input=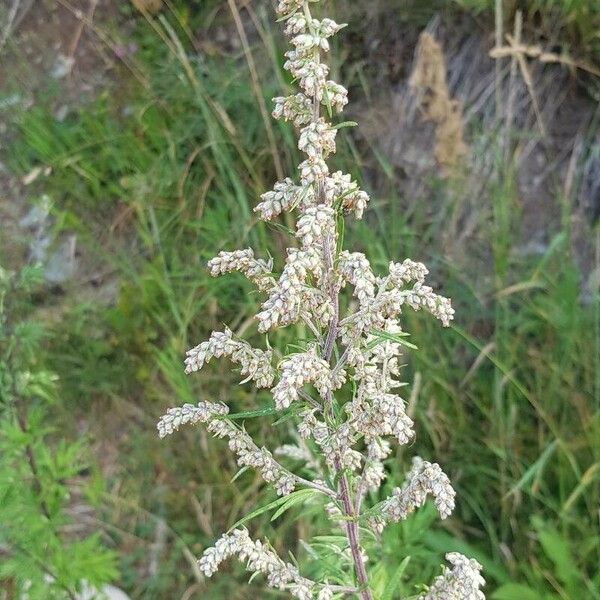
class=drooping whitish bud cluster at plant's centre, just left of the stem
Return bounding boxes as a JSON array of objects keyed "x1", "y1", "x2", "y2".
[{"x1": 271, "y1": 346, "x2": 331, "y2": 410}]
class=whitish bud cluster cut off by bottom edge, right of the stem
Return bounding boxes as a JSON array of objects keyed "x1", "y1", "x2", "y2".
[{"x1": 418, "y1": 552, "x2": 485, "y2": 600}]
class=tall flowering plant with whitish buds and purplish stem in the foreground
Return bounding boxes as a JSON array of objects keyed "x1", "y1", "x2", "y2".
[{"x1": 158, "y1": 0, "x2": 483, "y2": 600}]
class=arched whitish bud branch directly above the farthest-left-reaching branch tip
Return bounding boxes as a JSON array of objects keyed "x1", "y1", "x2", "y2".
[{"x1": 185, "y1": 328, "x2": 275, "y2": 387}]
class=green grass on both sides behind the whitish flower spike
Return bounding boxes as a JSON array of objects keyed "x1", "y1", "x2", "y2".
[{"x1": 1, "y1": 2, "x2": 600, "y2": 600}]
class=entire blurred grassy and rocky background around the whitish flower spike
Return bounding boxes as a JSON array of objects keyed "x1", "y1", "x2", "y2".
[{"x1": 0, "y1": 0, "x2": 600, "y2": 600}]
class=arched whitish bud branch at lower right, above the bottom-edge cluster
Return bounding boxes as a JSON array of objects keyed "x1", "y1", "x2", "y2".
[{"x1": 383, "y1": 456, "x2": 456, "y2": 522}]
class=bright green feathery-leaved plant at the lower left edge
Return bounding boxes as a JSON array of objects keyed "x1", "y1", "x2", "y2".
[{"x1": 0, "y1": 268, "x2": 117, "y2": 600}]
